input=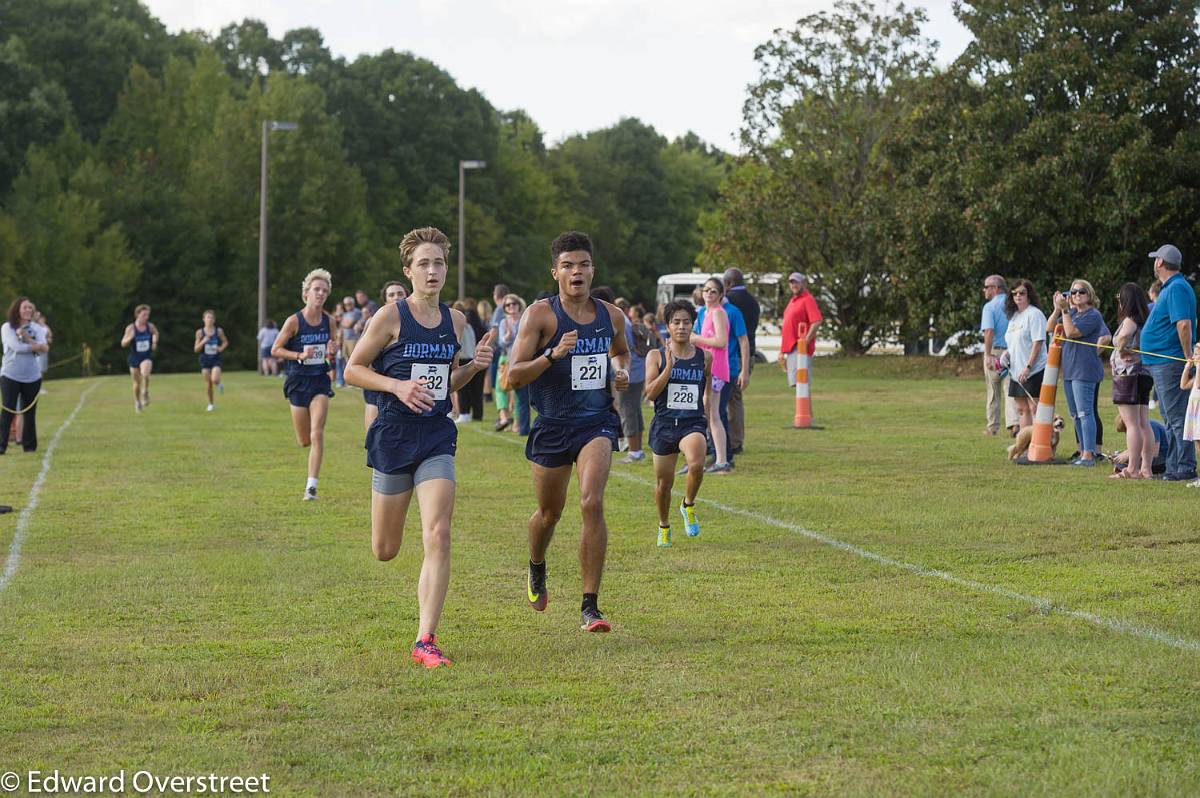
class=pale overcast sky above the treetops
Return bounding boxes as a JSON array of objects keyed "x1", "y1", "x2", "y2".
[{"x1": 143, "y1": 0, "x2": 970, "y2": 150}]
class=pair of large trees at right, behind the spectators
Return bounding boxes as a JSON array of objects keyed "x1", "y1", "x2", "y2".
[{"x1": 701, "y1": 0, "x2": 1200, "y2": 352}]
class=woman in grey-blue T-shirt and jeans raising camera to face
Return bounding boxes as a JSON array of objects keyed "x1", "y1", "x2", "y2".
[{"x1": 1046, "y1": 280, "x2": 1112, "y2": 468}]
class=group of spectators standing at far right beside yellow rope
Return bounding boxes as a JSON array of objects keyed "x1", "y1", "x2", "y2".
[{"x1": 979, "y1": 244, "x2": 1200, "y2": 487}]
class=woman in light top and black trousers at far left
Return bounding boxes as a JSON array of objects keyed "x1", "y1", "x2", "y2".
[{"x1": 0, "y1": 296, "x2": 50, "y2": 455}]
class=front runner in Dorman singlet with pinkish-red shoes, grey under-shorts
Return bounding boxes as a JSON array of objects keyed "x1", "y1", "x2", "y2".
[{"x1": 346, "y1": 227, "x2": 496, "y2": 667}]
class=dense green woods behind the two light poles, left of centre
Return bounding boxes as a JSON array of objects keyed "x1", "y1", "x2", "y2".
[{"x1": 0, "y1": 0, "x2": 730, "y2": 368}]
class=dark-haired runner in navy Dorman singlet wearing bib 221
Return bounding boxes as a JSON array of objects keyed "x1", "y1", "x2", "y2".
[{"x1": 509, "y1": 232, "x2": 629, "y2": 631}]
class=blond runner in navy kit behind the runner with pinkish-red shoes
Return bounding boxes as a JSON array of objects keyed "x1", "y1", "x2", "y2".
[{"x1": 271, "y1": 269, "x2": 334, "y2": 502}]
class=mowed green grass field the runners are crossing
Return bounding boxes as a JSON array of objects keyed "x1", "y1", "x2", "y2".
[{"x1": 0, "y1": 359, "x2": 1200, "y2": 796}]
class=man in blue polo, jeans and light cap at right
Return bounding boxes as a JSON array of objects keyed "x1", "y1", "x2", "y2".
[{"x1": 1141, "y1": 244, "x2": 1196, "y2": 481}]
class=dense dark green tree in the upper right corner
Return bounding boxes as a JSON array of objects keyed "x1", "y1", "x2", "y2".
[{"x1": 940, "y1": 0, "x2": 1200, "y2": 317}]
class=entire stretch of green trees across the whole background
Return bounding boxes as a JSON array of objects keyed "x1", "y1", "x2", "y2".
[{"x1": 0, "y1": 0, "x2": 1200, "y2": 367}]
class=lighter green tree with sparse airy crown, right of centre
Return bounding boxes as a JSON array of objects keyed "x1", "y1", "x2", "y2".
[{"x1": 706, "y1": 0, "x2": 934, "y2": 353}]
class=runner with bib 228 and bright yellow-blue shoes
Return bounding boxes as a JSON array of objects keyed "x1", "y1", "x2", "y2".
[{"x1": 646, "y1": 300, "x2": 713, "y2": 547}]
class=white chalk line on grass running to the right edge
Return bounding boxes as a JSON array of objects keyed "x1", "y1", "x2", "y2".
[{"x1": 474, "y1": 430, "x2": 1200, "y2": 652}]
